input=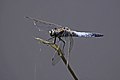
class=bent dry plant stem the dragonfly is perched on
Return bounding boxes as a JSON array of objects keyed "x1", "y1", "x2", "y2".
[{"x1": 35, "y1": 38, "x2": 78, "y2": 80}]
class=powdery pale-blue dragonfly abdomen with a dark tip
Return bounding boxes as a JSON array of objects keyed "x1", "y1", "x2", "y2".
[{"x1": 72, "y1": 31, "x2": 103, "y2": 37}]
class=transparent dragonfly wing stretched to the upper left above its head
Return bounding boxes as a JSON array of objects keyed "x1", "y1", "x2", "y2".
[{"x1": 25, "y1": 17, "x2": 62, "y2": 31}]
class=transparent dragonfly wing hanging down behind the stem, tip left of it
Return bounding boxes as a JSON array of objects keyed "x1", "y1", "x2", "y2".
[{"x1": 52, "y1": 41, "x2": 64, "y2": 66}]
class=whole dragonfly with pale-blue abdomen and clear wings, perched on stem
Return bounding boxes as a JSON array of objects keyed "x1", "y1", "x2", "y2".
[{"x1": 26, "y1": 17, "x2": 103, "y2": 65}]
